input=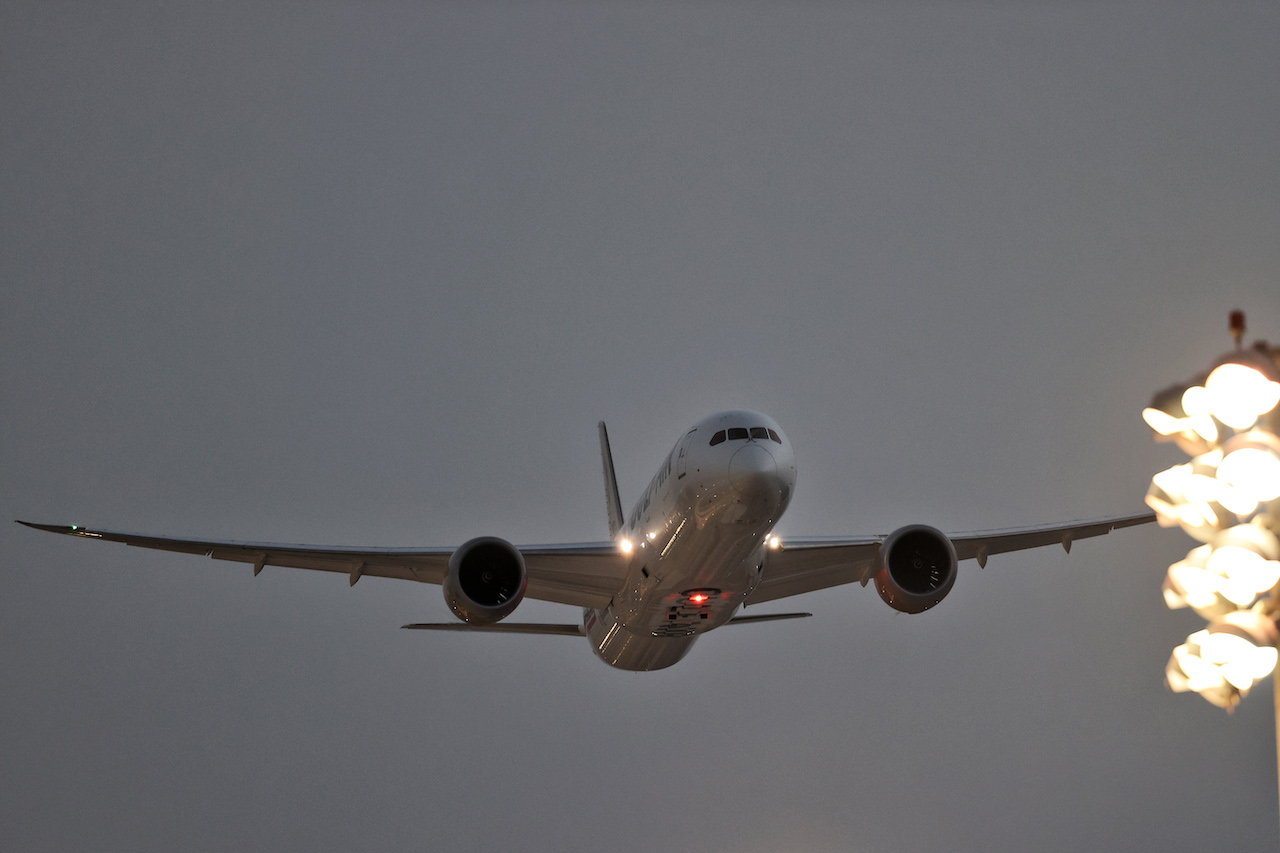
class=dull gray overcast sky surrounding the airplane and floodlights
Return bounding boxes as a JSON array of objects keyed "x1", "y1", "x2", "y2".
[{"x1": 0, "y1": 3, "x2": 1280, "y2": 853}]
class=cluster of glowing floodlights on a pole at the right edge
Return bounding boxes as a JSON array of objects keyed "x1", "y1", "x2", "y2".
[{"x1": 1142, "y1": 311, "x2": 1280, "y2": 809}]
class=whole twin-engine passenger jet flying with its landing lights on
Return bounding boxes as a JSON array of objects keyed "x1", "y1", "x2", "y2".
[{"x1": 18, "y1": 410, "x2": 1156, "y2": 671}]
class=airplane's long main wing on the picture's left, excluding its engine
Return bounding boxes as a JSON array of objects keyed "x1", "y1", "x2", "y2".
[{"x1": 18, "y1": 521, "x2": 627, "y2": 607}]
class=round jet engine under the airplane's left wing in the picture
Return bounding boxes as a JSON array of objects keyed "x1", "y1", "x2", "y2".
[{"x1": 443, "y1": 537, "x2": 529, "y2": 625}]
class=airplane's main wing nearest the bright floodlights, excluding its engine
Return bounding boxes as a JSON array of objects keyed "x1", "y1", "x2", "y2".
[{"x1": 746, "y1": 512, "x2": 1156, "y2": 605}]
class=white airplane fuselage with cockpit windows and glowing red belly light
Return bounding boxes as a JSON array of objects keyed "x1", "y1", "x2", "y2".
[{"x1": 582, "y1": 410, "x2": 796, "y2": 670}]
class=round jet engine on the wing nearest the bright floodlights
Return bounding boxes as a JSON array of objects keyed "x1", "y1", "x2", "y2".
[{"x1": 876, "y1": 524, "x2": 959, "y2": 613}]
